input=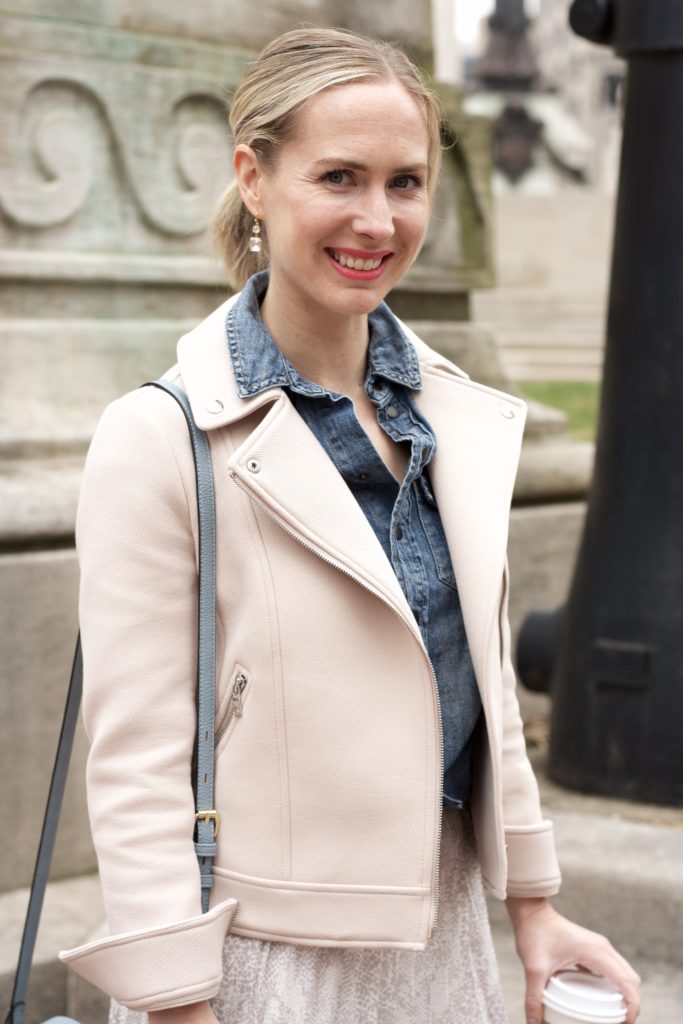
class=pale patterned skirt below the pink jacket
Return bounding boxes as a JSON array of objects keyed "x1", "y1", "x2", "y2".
[{"x1": 110, "y1": 811, "x2": 508, "y2": 1024}]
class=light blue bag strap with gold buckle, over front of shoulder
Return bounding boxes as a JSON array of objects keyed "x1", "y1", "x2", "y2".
[{"x1": 147, "y1": 380, "x2": 219, "y2": 913}]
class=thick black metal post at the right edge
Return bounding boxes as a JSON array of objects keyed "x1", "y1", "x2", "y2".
[{"x1": 549, "y1": 0, "x2": 683, "y2": 805}]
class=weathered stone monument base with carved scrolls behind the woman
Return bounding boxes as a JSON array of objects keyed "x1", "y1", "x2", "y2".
[{"x1": 0, "y1": 0, "x2": 492, "y2": 892}]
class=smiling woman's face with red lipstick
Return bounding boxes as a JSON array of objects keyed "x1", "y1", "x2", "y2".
[{"x1": 242, "y1": 82, "x2": 429, "y2": 315}]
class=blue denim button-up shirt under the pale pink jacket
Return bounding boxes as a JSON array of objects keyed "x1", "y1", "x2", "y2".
[{"x1": 226, "y1": 270, "x2": 481, "y2": 807}]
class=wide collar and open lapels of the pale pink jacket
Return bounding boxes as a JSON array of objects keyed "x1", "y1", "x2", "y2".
[{"x1": 178, "y1": 299, "x2": 525, "y2": 667}]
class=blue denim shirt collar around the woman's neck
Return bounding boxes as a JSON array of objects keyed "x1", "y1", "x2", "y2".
[{"x1": 226, "y1": 270, "x2": 422, "y2": 398}]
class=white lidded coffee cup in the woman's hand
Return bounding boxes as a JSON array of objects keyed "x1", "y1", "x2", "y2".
[{"x1": 543, "y1": 971, "x2": 626, "y2": 1024}]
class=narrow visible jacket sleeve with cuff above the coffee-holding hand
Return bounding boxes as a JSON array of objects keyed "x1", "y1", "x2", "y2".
[{"x1": 501, "y1": 564, "x2": 560, "y2": 896}]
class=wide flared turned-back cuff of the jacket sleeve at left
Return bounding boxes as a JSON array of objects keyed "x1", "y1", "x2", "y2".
[{"x1": 59, "y1": 899, "x2": 238, "y2": 1011}]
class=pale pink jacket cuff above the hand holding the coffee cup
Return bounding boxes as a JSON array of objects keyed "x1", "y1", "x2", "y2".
[{"x1": 505, "y1": 820, "x2": 561, "y2": 897}]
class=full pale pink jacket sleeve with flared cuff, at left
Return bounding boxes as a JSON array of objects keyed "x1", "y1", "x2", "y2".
[{"x1": 60, "y1": 388, "x2": 237, "y2": 1011}]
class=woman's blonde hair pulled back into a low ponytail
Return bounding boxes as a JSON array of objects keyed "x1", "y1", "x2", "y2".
[{"x1": 213, "y1": 29, "x2": 442, "y2": 288}]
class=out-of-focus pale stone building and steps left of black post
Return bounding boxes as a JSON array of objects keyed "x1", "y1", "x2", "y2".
[{"x1": 461, "y1": 0, "x2": 624, "y2": 382}]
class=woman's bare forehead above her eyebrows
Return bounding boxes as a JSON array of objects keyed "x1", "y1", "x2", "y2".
[{"x1": 285, "y1": 80, "x2": 429, "y2": 163}]
